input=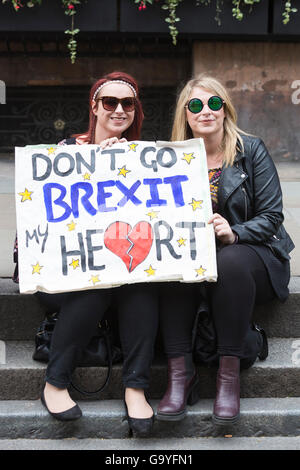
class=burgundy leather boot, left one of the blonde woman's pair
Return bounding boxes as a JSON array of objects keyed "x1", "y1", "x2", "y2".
[{"x1": 157, "y1": 354, "x2": 199, "y2": 421}]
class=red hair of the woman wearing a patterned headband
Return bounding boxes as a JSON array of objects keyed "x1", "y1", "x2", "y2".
[{"x1": 72, "y1": 72, "x2": 144, "y2": 144}]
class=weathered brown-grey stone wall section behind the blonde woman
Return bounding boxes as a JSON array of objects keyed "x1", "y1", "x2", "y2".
[{"x1": 193, "y1": 42, "x2": 300, "y2": 162}]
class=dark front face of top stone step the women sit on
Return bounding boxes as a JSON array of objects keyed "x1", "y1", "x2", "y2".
[{"x1": 0, "y1": 277, "x2": 300, "y2": 341}]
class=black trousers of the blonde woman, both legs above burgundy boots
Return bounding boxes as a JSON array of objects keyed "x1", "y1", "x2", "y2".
[{"x1": 160, "y1": 244, "x2": 275, "y2": 357}]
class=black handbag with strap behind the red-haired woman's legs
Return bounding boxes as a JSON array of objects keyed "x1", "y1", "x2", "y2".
[{"x1": 32, "y1": 313, "x2": 122, "y2": 395}]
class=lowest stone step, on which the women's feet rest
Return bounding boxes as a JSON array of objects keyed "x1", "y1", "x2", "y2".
[{"x1": 0, "y1": 397, "x2": 300, "y2": 442}]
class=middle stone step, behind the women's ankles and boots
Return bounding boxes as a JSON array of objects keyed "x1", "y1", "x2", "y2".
[{"x1": 0, "y1": 338, "x2": 300, "y2": 400}]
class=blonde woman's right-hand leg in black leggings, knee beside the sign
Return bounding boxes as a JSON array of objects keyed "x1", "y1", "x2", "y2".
[{"x1": 207, "y1": 244, "x2": 275, "y2": 356}]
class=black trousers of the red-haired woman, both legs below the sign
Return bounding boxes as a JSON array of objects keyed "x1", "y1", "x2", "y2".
[{"x1": 38, "y1": 283, "x2": 158, "y2": 388}]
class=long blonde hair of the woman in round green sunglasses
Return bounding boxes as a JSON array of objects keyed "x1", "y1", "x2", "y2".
[{"x1": 171, "y1": 74, "x2": 246, "y2": 166}]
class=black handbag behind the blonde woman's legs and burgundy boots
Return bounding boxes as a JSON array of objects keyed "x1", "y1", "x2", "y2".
[{"x1": 193, "y1": 302, "x2": 268, "y2": 369}]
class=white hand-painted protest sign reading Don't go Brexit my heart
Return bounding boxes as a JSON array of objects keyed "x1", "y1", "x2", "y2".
[{"x1": 16, "y1": 139, "x2": 217, "y2": 293}]
